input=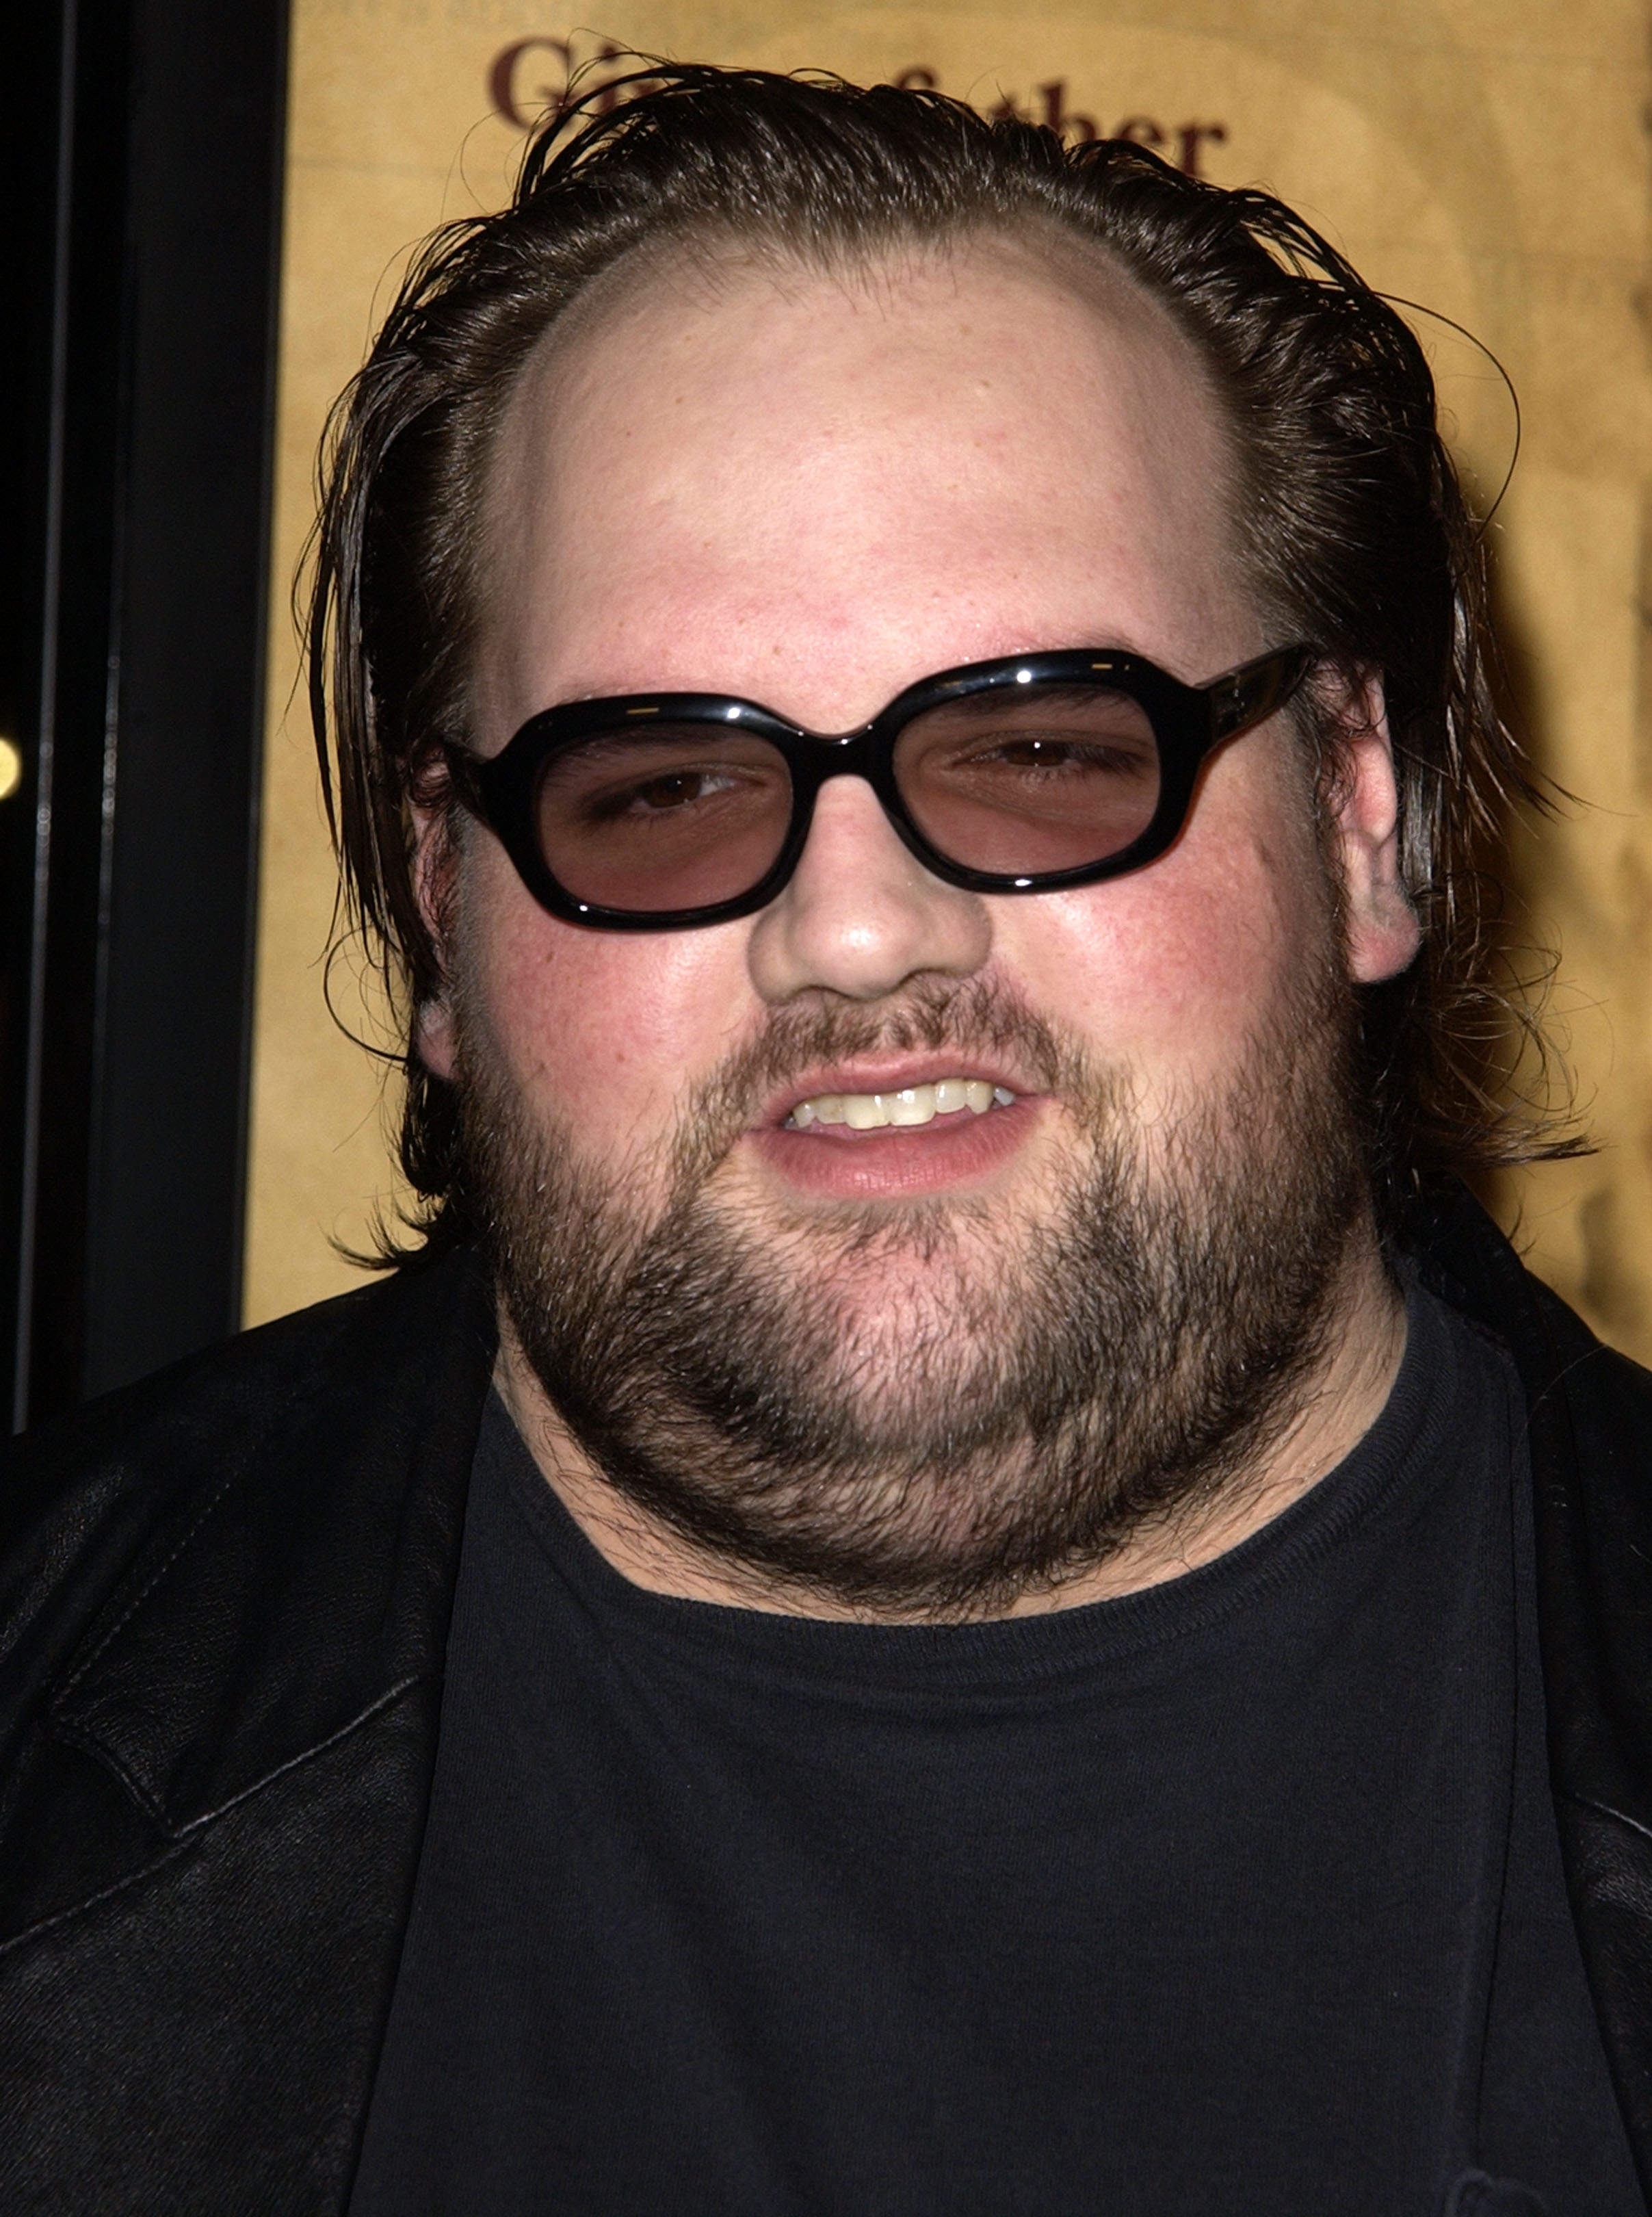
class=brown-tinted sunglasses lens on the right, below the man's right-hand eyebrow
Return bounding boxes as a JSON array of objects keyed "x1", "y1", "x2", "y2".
[{"x1": 893, "y1": 685, "x2": 1162, "y2": 878}]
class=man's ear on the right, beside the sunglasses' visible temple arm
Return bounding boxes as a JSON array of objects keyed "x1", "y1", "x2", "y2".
[{"x1": 1322, "y1": 672, "x2": 1421, "y2": 985}]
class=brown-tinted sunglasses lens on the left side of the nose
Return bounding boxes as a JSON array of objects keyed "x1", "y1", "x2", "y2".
[{"x1": 534, "y1": 723, "x2": 791, "y2": 913}]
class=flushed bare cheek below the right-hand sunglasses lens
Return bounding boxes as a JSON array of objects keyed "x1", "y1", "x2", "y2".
[{"x1": 995, "y1": 744, "x2": 1330, "y2": 1091}]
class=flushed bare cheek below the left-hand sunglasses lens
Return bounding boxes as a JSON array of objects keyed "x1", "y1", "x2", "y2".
[{"x1": 463, "y1": 858, "x2": 750, "y2": 1155}]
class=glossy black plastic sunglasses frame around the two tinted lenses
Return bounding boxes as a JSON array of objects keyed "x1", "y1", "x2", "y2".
[{"x1": 443, "y1": 645, "x2": 1317, "y2": 931}]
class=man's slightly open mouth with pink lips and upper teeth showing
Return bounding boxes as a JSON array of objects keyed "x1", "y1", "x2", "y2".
[{"x1": 750, "y1": 1055, "x2": 1040, "y2": 1202}]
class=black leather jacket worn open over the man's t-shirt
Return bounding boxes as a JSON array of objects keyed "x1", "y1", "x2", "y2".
[{"x1": 0, "y1": 1200, "x2": 1652, "y2": 2217}]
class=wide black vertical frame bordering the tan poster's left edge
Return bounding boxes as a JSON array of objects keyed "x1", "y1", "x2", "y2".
[{"x1": 82, "y1": 0, "x2": 288, "y2": 1392}]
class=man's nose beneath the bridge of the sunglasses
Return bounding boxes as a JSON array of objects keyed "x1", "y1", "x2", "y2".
[{"x1": 747, "y1": 776, "x2": 991, "y2": 1004}]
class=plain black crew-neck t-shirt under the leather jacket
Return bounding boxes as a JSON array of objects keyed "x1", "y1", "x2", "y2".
[{"x1": 350, "y1": 1293, "x2": 1643, "y2": 2217}]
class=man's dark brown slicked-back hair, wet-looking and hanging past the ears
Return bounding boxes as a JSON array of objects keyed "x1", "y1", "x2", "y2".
[{"x1": 309, "y1": 64, "x2": 1570, "y2": 1259}]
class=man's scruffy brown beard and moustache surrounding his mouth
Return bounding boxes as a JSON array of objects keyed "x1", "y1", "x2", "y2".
[{"x1": 457, "y1": 949, "x2": 1368, "y2": 1616}]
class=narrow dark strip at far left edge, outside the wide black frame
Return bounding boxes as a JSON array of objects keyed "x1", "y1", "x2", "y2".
[{"x1": 0, "y1": 0, "x2": 131, "y2": 1425}]
